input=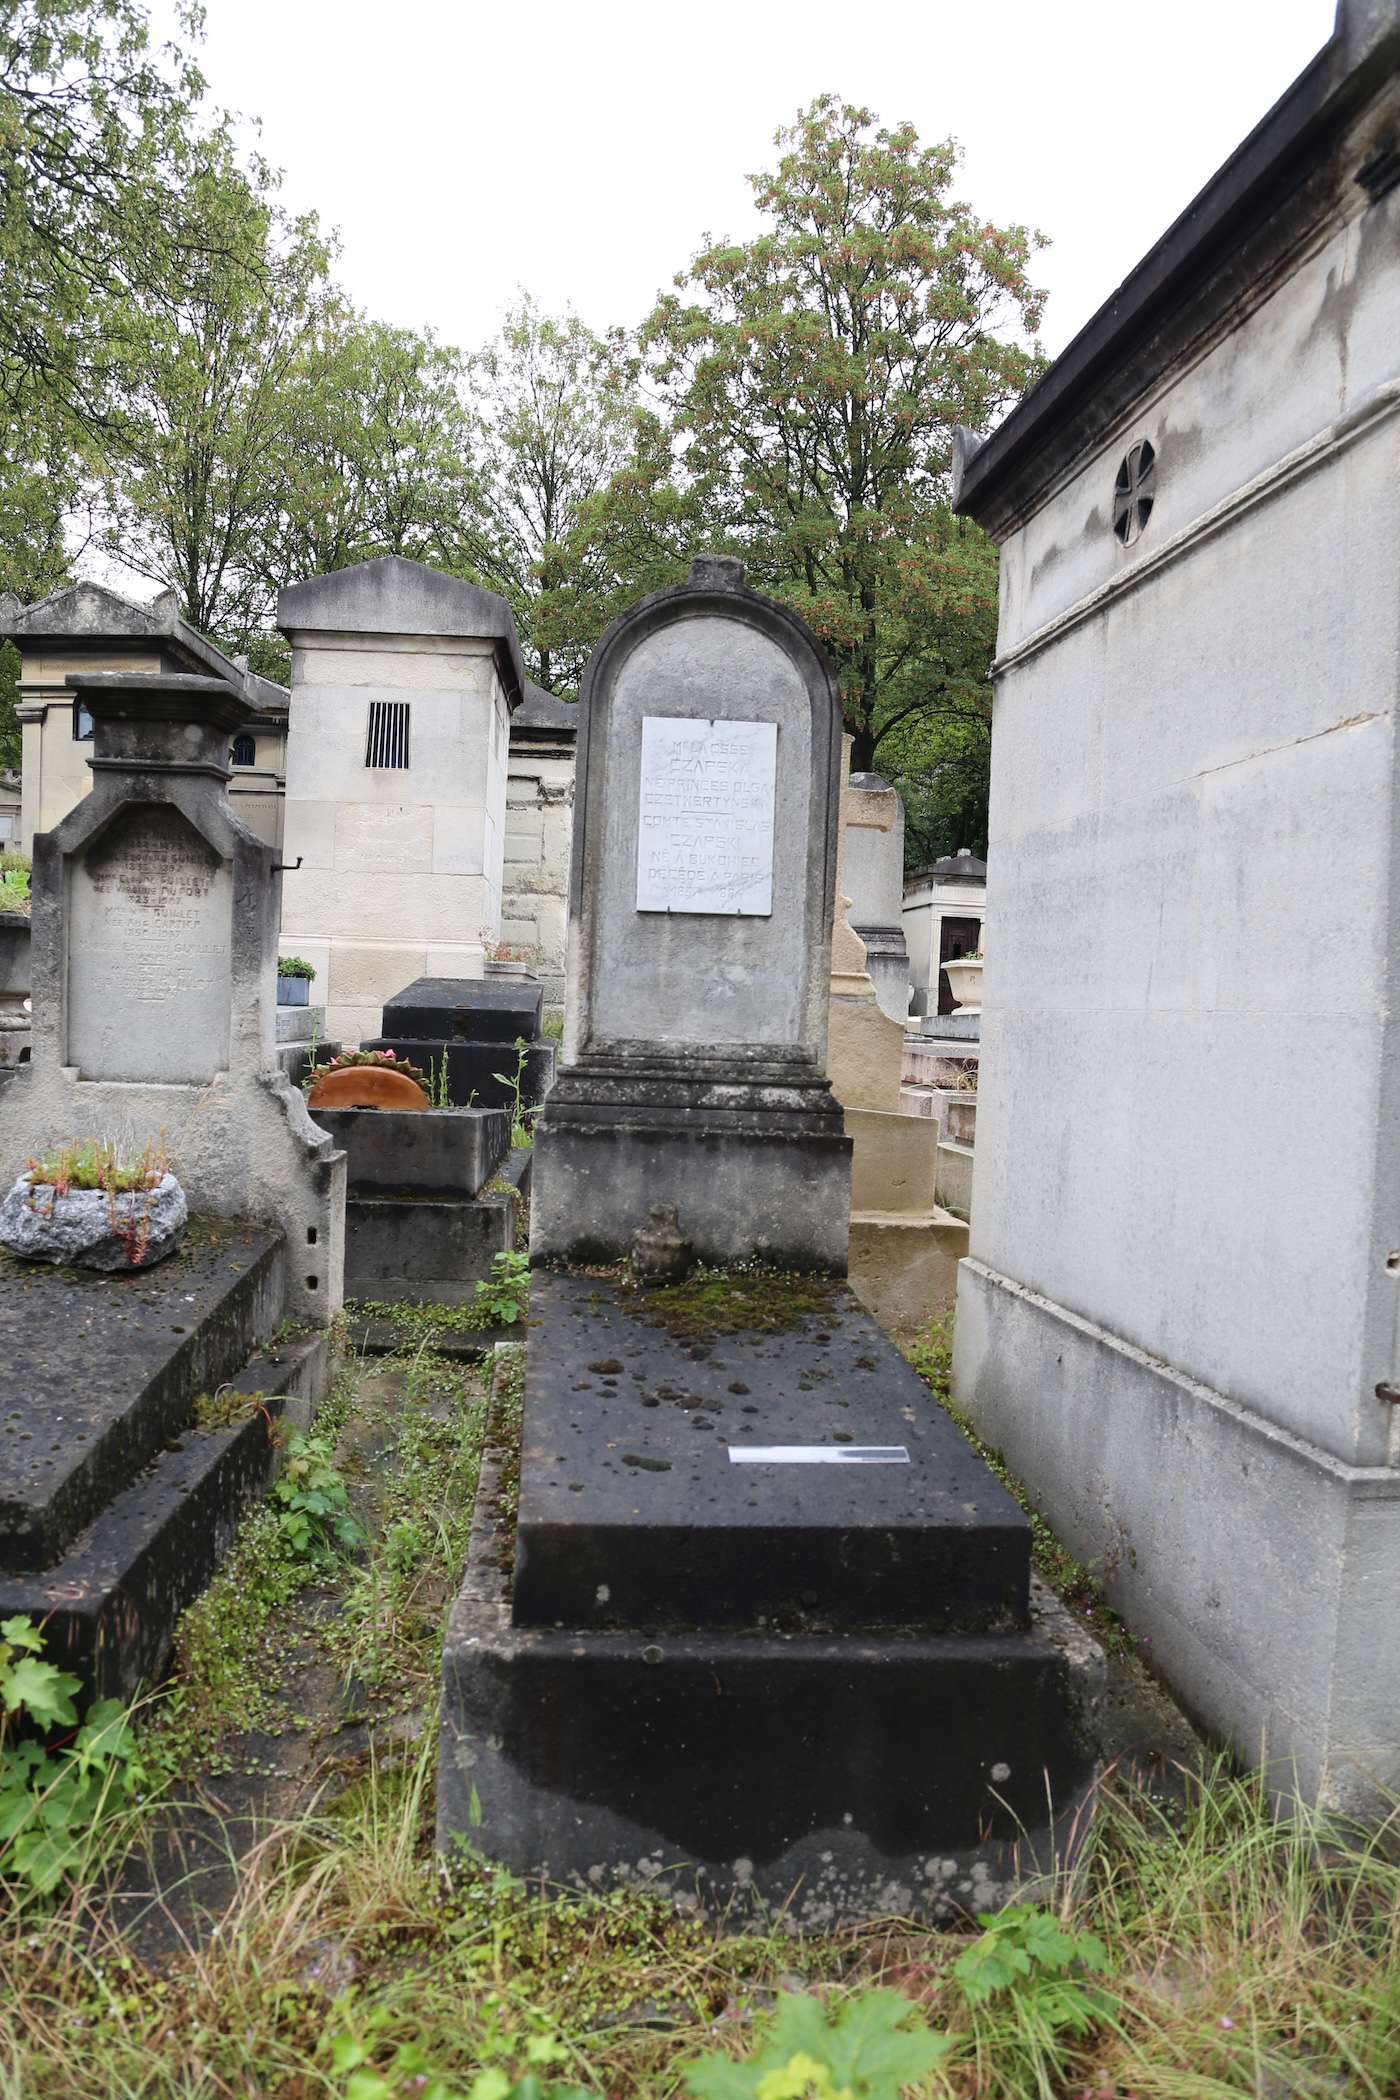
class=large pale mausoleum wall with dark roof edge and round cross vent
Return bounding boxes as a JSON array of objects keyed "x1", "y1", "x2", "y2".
[{"x1": 955, "y1": 0, "x2": 1400, "y2": 1810}]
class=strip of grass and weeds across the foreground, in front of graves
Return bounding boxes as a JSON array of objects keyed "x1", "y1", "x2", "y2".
[{"x1": 0, "y1": 1696, "x2": 1400, "y2": 2100}]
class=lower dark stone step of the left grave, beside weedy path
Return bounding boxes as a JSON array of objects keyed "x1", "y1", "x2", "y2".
[{"x1": 0, "y1": 1334, "x2": 327, "y2": 1699}]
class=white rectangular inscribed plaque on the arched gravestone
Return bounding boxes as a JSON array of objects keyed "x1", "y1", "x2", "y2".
[{"x1": 636, "y1": 714, "x2": 779, "y2": 918}]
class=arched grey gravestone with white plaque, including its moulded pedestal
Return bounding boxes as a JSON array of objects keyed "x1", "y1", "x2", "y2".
[{"x1": 531, "y1": 554, "x2": 850, "y2": 1275}]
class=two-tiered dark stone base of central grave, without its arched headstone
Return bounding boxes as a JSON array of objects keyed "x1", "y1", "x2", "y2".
[{"x1": 439, "y1": 1275, "x2": 1102, "y2": 1928}]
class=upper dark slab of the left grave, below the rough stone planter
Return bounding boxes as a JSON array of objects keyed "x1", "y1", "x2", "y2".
[{"x1": 0, "y1": 1218, "x2": 283, "y2": 1573}]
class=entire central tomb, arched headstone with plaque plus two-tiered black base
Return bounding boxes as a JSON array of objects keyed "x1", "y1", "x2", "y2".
[{"x1": 439, "y1": 557, "x2": 1102, "y2": 1926}]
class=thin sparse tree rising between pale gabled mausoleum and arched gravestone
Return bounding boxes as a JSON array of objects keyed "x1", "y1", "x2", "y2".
[{"x1": 468, "y1": 296, "x2": 638, "y2": 693}]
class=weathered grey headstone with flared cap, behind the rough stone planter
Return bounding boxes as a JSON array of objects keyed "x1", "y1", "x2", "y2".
[{"x1": 0, "y1": 672, "x2": 344, "y2": 1323}]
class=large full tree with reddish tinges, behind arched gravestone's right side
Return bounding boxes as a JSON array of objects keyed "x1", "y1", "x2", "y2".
[{"x1": 642, "y1": 95, "x2": 1043, "y2": 771}]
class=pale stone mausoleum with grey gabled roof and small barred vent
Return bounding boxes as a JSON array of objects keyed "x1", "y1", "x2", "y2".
[{"x1": 277, "y1": 554, "x2": 525, "y2": 1042}]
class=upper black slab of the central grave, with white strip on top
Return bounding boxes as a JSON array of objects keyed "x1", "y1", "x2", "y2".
[{"x1": 514, "y1": 1271, "x2": 1031, "y2": 1632}]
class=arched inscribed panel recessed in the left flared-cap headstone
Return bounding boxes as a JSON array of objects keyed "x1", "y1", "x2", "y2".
[{"x1": 67, "y1": 804, "x2": 233, "y2": 1084}]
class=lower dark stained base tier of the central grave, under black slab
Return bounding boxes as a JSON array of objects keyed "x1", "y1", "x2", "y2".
[{"x1": 437, "y1": 1340, "x2": 1104, "y2": 1930}]
